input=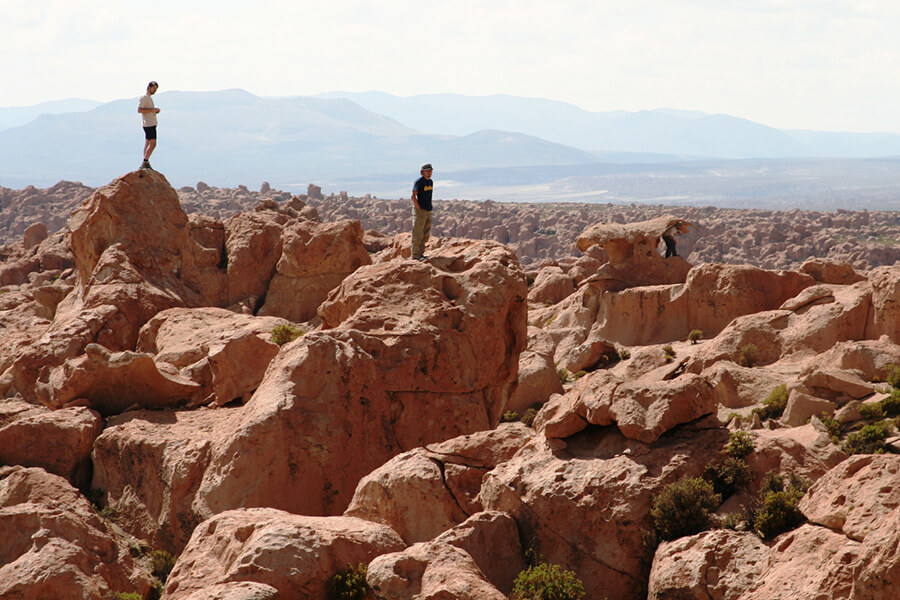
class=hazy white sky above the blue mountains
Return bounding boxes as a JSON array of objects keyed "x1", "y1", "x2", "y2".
[{"x1": 0, "y1": 0, "x2": 900, "y2": 132}]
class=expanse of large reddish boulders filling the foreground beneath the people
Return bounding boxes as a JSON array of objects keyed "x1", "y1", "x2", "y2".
[{"x1": 0, "y1": 170, "x2": 900, "y2": 600}]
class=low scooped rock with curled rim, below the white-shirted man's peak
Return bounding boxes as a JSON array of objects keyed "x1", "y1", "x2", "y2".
[{"x1": 36, "y1": 344, "x2": 201, "y2": 415}]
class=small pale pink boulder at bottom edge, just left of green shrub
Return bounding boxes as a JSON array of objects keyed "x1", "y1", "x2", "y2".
[{"x1": 366, "y1": 540, "x2": 506, "y2": 600}]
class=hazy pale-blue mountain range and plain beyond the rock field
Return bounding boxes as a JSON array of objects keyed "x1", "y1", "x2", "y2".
[{"x1": 0, "y1": 90, "x2": 900, "y2": 207}]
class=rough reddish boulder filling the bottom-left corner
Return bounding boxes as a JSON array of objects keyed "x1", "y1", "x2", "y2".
[{"x1": 0, "y1": 467, "x2": 151, "y2": 600}]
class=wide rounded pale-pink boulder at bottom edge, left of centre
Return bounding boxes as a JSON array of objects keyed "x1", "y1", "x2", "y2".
[{"x1": 163, "y1": 508, "x2": 403, "y2": 600}]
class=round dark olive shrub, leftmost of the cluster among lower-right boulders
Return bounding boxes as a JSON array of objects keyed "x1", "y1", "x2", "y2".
[{"x1": 650, "y1": 477, "x2": 722, "y2": 540}]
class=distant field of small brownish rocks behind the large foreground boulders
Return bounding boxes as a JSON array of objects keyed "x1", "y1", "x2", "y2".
[{"x1": 0, "y1": 181, "x2": 900, "y2": 270}]
